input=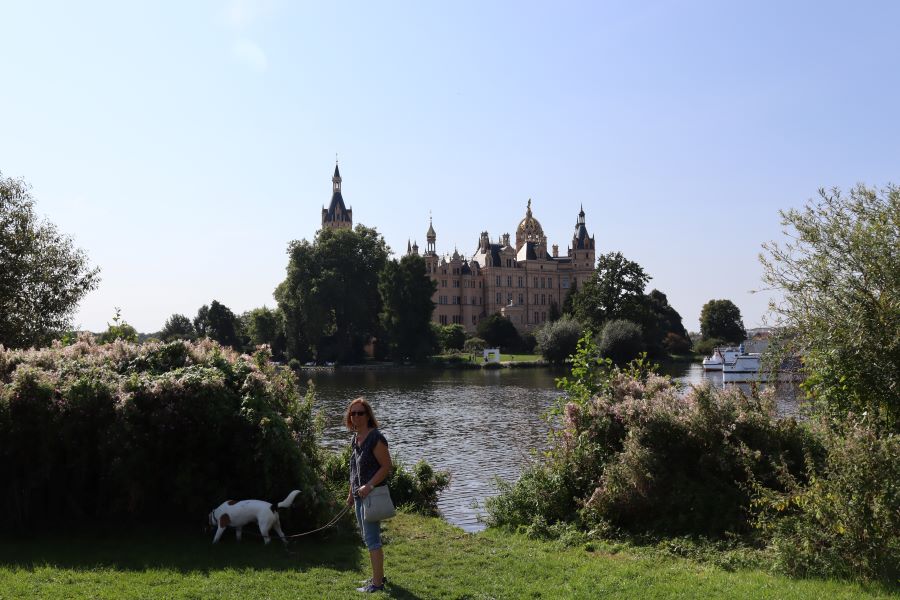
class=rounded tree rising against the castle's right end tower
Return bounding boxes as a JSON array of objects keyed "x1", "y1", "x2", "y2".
[{"x1": 572, "y1": 252, "x2": 651, "y2": 331}]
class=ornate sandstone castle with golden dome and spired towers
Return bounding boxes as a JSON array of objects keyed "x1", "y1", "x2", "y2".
[{"x1": 322, "y1": 166, "x2": 595, "y2": 333}]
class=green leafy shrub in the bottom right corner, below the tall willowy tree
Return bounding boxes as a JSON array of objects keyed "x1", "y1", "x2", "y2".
[{"x1": 755, "y1": 422, "x2": 900, "y2": 582}]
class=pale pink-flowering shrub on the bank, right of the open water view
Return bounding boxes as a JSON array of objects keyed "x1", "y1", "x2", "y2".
[{"x1": 486, "y1": 336, "x2": 821, "y2": 536}]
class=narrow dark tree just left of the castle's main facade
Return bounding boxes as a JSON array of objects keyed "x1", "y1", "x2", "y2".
[{"x1": 378, "y1": 254, "x2": 438, "y2": 360}]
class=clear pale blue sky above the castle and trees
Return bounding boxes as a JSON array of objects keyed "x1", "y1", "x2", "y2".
[{"x1": 0, "y1": 0, "x2": 900, "y2": 332}]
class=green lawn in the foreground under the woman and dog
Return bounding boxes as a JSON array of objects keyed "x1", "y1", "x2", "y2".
[{"x1": 0, "y1": 514, "x2": 891, "y2": 600}]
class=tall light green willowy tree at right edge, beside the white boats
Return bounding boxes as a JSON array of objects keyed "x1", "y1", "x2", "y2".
[{"x1": 761, "y1": 185, "x2": 900, "y2": 431}]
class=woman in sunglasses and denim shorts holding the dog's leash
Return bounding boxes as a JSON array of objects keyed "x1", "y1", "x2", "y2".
[{"x1": 345, "y1": 398, "x2": 391, "y2": 592}]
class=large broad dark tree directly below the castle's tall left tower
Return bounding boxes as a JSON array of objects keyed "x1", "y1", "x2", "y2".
[{"x1": 275, "y1": 225, "x2": 389, "y2": 361}]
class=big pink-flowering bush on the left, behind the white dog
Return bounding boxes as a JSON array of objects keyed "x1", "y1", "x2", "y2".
[{"x1": 0, "y1": 335, "x2": 330, "y2": 530}]
